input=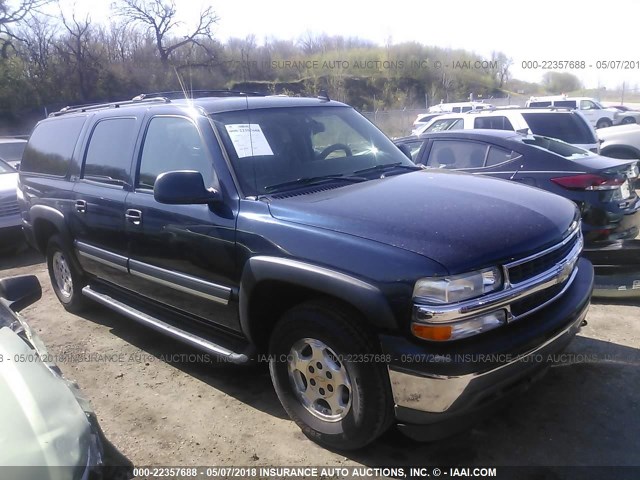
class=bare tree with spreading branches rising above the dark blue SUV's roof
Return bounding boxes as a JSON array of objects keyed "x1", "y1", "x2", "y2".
[{"x1": 115, "y1": 0, "x2": 218, "y2": 67}]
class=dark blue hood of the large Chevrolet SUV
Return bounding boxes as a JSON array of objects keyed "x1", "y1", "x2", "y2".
[{"x1": 269, "y1": 170, "x2": 576, "y2": 274}]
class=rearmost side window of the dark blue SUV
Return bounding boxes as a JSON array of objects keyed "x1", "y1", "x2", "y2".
[{"x1": 20, "y1": 117, "x2": 86, "y2": 177}]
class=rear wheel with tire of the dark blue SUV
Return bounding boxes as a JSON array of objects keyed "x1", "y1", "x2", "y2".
[{"x1": 47, "y1": 235, "x2": 89, "y2": 313}]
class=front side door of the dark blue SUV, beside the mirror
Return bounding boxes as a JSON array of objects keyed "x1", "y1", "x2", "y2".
[{"x1": 125, "y1": 115, "x2": 239, "y2": 330}]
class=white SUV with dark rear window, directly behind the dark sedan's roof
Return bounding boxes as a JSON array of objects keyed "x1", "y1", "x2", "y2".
[{"x1": 414, "y1": 108, "x2": 600, "y2": 153}]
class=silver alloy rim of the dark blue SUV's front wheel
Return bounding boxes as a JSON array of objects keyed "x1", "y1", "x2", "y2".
[{"x1": 287, "y1": 338, "x2": 352, "y2": 422}]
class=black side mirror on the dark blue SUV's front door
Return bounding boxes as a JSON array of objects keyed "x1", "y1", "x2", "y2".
[{"x1": 153, "y1": 170, "x2": 221, "y2": 205}]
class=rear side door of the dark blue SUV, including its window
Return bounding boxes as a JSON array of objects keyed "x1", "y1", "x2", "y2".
[{"x1": 71, "y1": 116, "x2": 141, "y2": 284}]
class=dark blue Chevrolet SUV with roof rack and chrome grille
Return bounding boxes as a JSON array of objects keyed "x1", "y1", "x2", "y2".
[{"x1": 19, "y1": 91, "x2": 593, "y2": 449}]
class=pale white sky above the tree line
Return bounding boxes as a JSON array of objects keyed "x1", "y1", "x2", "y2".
[{"x1": 56, "y1": 0, "x2": 640, "y2": 89}]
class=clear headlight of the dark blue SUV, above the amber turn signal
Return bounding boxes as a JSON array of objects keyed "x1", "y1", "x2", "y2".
[{"x1": 413, "y1": 267, "x2": 502, "y2": 305}]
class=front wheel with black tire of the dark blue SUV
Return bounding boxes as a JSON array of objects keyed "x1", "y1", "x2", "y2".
[{"x1": 269, "y1": 301, "x2": 393, "y2": 450}]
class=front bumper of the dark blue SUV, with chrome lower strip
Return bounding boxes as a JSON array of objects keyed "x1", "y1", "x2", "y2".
[{"x1": 381, "y1": 260, "x2": 594, "y2": 440}]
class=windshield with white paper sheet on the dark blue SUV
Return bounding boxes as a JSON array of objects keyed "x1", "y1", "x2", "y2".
[{"x1": 211, "y1": 107, "x2": 416, "y2": 196}]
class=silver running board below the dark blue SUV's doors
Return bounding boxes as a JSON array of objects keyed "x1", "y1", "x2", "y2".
[{"x1": 82, "y1": 286, "x2": 249, "y2": 363}]
